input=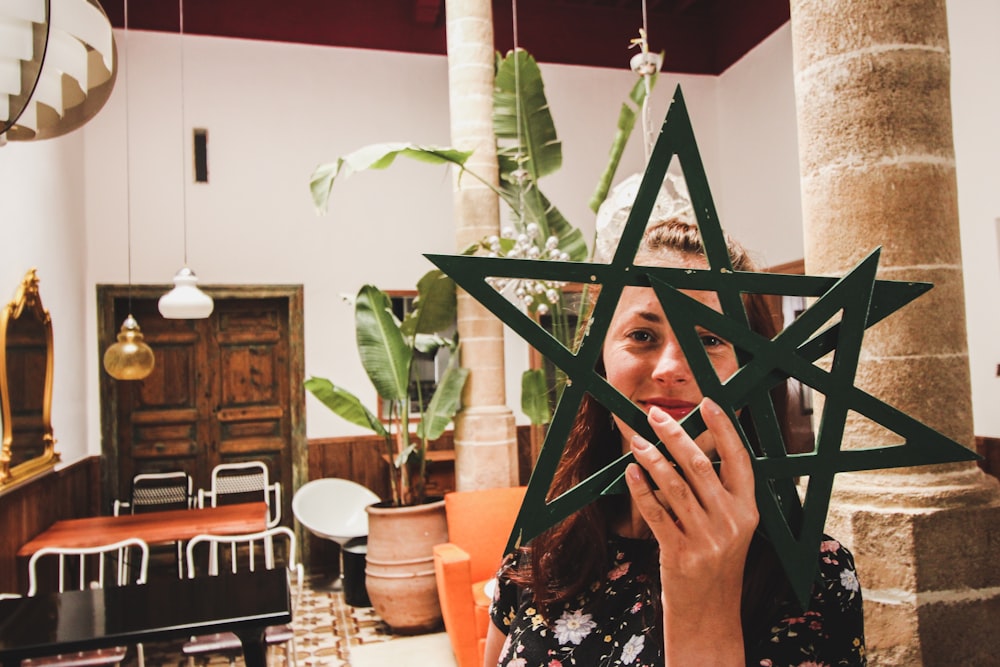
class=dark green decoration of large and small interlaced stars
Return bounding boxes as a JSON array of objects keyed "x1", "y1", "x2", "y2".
[{"x1": 427, "y1": 87, "x2": 978, "y2": 608}]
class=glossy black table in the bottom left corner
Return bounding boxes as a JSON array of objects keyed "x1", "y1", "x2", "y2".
[{"x1": 0, "y1": 568, "x2": 292, "y2": 667}]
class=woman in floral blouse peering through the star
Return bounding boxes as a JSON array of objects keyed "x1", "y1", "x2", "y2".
[{"x1": 484, "y1": 218, "x2": 866, "y2": 667}]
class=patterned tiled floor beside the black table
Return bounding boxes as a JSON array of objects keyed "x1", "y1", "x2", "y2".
[{"x1": 135, "y1": 577, "x2": 412, "y2": 667}]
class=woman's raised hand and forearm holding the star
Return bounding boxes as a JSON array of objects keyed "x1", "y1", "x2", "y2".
[{"x1": 625, "y1": 398, "x2": 759, "y2": 665}]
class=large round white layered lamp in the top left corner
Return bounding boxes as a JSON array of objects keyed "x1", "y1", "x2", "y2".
[{"x1": 0, "y1": 0, "x2": 117, "y2": 141}]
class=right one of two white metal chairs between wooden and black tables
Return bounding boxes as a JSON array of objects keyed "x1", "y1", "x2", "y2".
[{"x1": 182, "y1": 526, "x2": 303, "y2": 667}]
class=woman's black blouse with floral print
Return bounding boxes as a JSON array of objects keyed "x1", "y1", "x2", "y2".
[{"x1": 490, "y1": 536, "x2": 867, "y2": 667}]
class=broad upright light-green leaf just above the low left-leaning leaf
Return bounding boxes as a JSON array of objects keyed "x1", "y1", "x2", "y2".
[{"x1": 354, "y1": 285, "x2": 413, "y2": 400}]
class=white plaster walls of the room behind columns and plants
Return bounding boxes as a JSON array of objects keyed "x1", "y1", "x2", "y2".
[{"x1": 0, "y1": 0, "x2": 1000, "y2": 468}]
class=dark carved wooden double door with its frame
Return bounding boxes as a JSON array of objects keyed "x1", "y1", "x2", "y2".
[{"x1": 98, "y1": 286, "x2": 307, "y2": 523}]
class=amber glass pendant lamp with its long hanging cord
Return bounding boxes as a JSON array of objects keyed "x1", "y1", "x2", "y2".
[{"x1": 104, "y1": 0, "x2": 156, "y2": 380}]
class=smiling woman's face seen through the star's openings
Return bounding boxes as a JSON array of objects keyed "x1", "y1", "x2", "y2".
[{"x1": 603, "y1": 253, "x2": 739, "y2": 455}]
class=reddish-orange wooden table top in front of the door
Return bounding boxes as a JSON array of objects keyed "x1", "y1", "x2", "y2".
[{"x1": 17, "y1": 503, "x2": 267, "y2": 556}]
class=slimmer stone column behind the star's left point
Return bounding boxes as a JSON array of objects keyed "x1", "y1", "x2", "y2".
[{"x1": 445, "y1": 0, "x2": 518, "y2": 490}]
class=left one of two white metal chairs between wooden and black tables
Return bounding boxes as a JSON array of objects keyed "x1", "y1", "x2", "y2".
[{"x1": 21, "y1": 537, "x2": 149, "y2": 667}]
